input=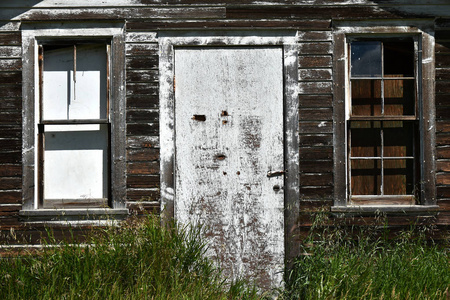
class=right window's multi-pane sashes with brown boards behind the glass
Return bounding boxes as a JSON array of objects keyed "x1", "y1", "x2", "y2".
[{"x1": 347, "y1": 37, "x2": 420, "y2": 205}]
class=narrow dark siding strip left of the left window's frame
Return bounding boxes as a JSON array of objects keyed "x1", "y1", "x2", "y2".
[{"x1": 0, "y1": 24, "x2": 22, "y2": 230}]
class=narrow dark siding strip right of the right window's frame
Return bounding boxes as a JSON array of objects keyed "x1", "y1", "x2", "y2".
[{"x1": 436, "y1": 19, "x2": 450, "y2": 225}]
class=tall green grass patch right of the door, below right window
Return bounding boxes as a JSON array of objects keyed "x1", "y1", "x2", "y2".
[{"x1": 283, "y1": 218, "x2": 450, "y2": 299}]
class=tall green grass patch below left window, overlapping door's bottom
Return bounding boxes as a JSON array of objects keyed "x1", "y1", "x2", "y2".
[{"x1": 0, "y1": 218, "x2": 258, "y2": 299}]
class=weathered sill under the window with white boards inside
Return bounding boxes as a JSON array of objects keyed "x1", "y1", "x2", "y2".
[{"x1": 19, "y1": 208, "x2": 129, "y2": 223}]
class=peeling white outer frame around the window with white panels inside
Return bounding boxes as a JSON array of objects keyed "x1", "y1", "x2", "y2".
[{"x1": 20, "y1": 22, "x2": 128, "y2": 220}]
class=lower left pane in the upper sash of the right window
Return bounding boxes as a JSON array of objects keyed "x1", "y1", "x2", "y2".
[{"x1": 351, "y1": 79, "x2": 381, "y2": 116}]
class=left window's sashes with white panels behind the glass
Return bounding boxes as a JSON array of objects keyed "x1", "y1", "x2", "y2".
[{"x1": 35, "y1": 41, "x2": 111, "y2": 208}]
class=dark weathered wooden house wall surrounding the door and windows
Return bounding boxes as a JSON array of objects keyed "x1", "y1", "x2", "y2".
[{"x1": 0, "y1": 0, "x2": 450, "y2": 290}]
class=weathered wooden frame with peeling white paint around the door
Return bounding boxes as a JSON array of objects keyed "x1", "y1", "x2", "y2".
[{"x1": 158, "y1": 30, "x2": 300, "y2": 268}]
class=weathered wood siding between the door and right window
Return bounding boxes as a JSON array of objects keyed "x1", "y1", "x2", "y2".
[{"x1": 298, "y1": 27, "x2": 333, "y2": 211}]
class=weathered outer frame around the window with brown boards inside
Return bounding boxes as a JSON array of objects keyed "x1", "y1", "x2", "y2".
[{"x1": 332, "y1": 21, "x2": 438, "y2": 212}]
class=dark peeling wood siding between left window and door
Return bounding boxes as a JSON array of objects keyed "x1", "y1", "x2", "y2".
[{"x1": 125, "y1": 29, "x2": 160, "y2": 214}]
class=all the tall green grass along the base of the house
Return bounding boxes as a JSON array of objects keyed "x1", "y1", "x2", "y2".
[{"x1": 0, "y1": 217, "x2": 450, "y2": 300}]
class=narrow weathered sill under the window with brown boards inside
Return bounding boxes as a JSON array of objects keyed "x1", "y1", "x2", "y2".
[{"x1": 331, "y1": 205, "x2": 439, "y2": 215}]
